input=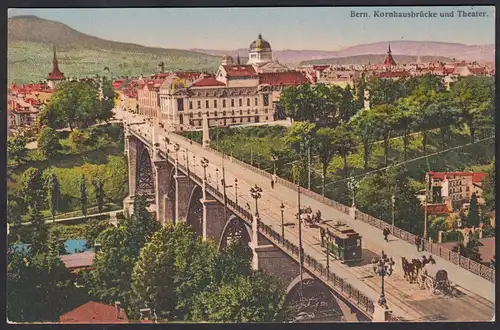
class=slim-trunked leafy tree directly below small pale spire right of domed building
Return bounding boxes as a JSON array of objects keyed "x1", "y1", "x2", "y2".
[{"x1": 349, "y1": 110, "x2": 377, "y2": 171}]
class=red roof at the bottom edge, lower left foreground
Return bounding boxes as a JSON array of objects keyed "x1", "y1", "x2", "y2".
[{"x1": 59, "y1": 301, "x2": 129, "y2": 324}]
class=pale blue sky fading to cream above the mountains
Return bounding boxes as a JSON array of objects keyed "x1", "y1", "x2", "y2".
[{"x1": 8, "y1": 6, "x2": 495, "y2": 51}]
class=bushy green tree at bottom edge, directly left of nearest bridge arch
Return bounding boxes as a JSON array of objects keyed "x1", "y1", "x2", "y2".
[{"x1": 193, "y1": 273, "x2": 284, "y2": 322}]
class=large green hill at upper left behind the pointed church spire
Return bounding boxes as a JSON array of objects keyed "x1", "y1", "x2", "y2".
[{"x1": 7, "y1": 16, "x2": 220, "y2": 83}]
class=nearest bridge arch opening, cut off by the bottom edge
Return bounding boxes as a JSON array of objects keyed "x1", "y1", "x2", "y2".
[{"x1": 282, "y1": 273, "x2": 351, "y2": 323}]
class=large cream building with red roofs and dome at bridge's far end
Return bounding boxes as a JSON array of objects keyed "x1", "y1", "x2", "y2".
[{"x1": 130, "y1": 34, "x2": 310, "y2": 131}]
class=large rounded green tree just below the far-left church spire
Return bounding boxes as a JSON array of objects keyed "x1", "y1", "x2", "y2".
[{"x1": 39, "y1": 81, "x2": 102, "y2": 130}]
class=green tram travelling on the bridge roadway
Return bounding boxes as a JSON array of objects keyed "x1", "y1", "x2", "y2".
[{"x1": 319, "y1": 221, "x2": 363, "y2": 263}]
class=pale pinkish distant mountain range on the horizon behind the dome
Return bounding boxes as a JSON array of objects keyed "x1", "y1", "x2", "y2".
[{"x1": 191, "y1": 41, "x2": 495, "y2": 63}]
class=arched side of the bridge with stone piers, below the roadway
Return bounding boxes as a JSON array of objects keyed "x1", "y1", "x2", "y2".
[{"x1": 124, "y1": 130, "x2": 373, "y2": 322}]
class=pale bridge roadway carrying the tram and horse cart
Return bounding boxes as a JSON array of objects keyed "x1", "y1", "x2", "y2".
[{"x1": 120, "y1": 113, "x2": 495, "y2": 321}]
